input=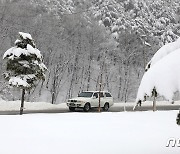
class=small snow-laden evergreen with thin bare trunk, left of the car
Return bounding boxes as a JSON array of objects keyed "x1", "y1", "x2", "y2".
[{"x1": 3, "y1": 32, "x2": 47, "y2": 114}]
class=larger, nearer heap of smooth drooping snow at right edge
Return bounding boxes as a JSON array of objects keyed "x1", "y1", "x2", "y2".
[{"x1": 136, "y1": 49, "x2": 180, "y2": 102}]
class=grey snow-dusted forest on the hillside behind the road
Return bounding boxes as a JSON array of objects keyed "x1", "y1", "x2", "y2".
[{"x1": 0, "y1": 0, "x2": 180, "y2": 103}]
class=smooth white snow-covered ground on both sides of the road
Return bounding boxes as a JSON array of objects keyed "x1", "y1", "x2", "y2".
[{"x1": 0, "y1": 101, "x2": 180, "y2": 154}]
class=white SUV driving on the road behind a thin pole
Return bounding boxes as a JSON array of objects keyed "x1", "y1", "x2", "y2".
[{"x1": 67, "y1": 91, "x2": 113, "y2": 112}]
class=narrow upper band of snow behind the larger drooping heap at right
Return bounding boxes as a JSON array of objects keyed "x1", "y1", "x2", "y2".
[{"x1": 146, "y1": 38, "x2": 180, "y2": 70}]
